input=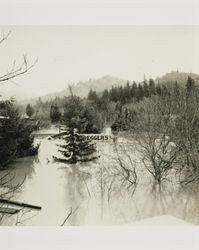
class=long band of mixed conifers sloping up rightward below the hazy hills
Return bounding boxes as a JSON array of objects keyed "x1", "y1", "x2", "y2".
[{"x1": 26, "y1": 79, "x2": 194, "y2": 133}]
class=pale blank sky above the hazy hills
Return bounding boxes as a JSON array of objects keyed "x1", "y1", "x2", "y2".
[{"x1": 0, "y1": 26, "x2": 199, "y2": 96}]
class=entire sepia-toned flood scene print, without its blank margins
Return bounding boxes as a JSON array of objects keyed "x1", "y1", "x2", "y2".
[{"x1": 0, "y1": 25, "x2": 199, "y2": 226}]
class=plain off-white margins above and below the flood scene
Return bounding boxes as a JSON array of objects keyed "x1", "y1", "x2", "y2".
[{"x1": 0, "y1": 0, "x2": 199, "y2": 250}]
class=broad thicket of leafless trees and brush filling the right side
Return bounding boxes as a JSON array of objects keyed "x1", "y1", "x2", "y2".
[{"x1": 126, "y1": 77, "x2": 199, "y2": 185}]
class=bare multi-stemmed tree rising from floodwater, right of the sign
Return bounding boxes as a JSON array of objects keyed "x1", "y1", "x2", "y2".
[{"x1": 136, "y1": 94, "x2": 179, "y2": 190}]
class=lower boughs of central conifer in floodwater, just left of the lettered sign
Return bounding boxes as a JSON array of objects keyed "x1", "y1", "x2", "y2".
[{"x1": 53, "y1": 128, "x2": 98, "y2": 164}]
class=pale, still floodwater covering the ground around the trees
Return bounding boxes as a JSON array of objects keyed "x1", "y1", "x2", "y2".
[{"x1": 1, "y1": 130, "x2": 199, "y2": 226}]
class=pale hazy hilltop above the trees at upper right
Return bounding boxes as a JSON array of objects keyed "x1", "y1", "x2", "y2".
[{"x1": 155, "y1": 71, "x2": 199, "y2": 85}]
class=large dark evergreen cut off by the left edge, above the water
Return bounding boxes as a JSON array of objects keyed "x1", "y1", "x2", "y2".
[{"x1": 0, "y1": 101, "x2": 39, "y2": 168}]
